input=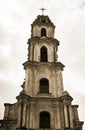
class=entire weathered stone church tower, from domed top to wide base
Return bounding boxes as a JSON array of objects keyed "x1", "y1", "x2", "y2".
[{"x1": 0, "y1": 11, "x2": 83, "y2": 130}]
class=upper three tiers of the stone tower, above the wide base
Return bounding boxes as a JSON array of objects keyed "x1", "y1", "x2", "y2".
[{"x1": 24, "y1": 15, "x2": 64, "y2": 97}]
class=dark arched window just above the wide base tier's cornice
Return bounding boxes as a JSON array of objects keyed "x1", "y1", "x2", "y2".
[{"x1": 40, "y1": 78, "x2": 49, "y2": 93}]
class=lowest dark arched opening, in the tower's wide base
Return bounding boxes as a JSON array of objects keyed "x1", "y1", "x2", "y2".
[{"x1": 39, "y1": 111, "x2": 50, "y2": 128}]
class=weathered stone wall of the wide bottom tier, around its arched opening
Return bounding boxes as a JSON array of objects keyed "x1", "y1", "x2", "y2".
[{"x1": 0, "y1": 92, "x2": 83, "y2": 130}]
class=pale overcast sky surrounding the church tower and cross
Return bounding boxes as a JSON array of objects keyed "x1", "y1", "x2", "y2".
[{"x1": 0, "y1": 0, "x2": 85, "y2": 129}]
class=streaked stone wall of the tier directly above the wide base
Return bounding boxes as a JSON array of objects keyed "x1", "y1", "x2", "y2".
[{"x1": 24, "y1": 63, "x2": 63, "y2": 97}]
